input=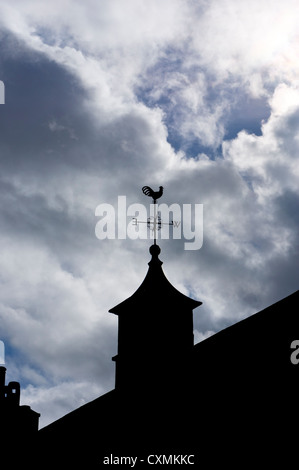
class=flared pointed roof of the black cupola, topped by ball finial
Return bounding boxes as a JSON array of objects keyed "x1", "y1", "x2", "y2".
[{"x1": 109, "y1": 245, "x2": 202, "y2": 315}]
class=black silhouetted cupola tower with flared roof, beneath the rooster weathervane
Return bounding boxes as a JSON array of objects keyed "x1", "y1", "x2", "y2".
[{"x1": 109, "y1": 245, "x2": 201, "y2": 393}]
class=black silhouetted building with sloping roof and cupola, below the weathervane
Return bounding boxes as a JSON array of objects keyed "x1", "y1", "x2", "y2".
[{"x1": 36, "y1": 245, "x2": 299, "y2": 468}]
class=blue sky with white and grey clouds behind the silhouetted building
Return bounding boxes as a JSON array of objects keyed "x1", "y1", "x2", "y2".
[{"x1": 0, "y1": 0, "x2": 299, "y2": 426}]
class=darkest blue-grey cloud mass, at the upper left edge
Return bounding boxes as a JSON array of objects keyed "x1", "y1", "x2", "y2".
[{"x1": 0, "y1": 33, "x2": 93, "y2": 173}]
